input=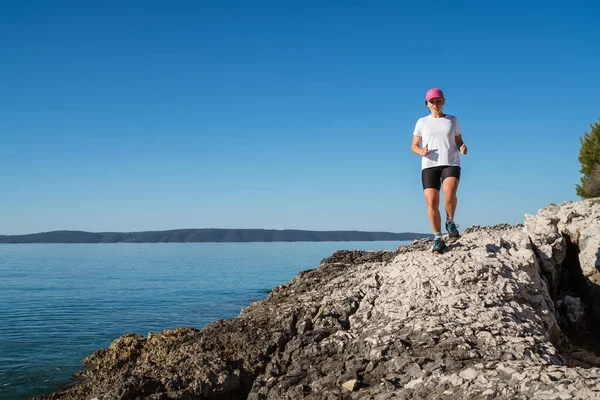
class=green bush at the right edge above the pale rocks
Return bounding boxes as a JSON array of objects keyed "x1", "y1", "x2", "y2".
[{"x1": 576, "y1": 118, "x2": 600, "y2": 199}]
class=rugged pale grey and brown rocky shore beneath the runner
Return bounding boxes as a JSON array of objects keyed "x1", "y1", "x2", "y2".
[{"x1": 36, "y1": 200, "x2": 600, "y2": 400}]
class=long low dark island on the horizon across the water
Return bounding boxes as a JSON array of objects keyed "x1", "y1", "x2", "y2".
[{"x1": 0, "y1": 228, "x2": 433, "y2": 243}]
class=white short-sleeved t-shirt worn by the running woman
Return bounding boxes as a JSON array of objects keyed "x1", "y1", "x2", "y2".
[{"x1": 413, "y1": 114, "x2": 460, "y2": 169}]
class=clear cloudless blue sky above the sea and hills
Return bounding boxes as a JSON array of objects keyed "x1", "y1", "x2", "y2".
[{"x1": 0, "y1": 0, "x2": 600, "y2": 234}]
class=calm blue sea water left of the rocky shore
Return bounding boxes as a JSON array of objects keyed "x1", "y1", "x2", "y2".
[{"x1": 0, "y1": 242, "x2": 408, "y2": 400}]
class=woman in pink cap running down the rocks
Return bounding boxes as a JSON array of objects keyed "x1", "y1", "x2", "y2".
[{"x1": 411, "y1": 88, "x2": 467, "y2": 254}]
